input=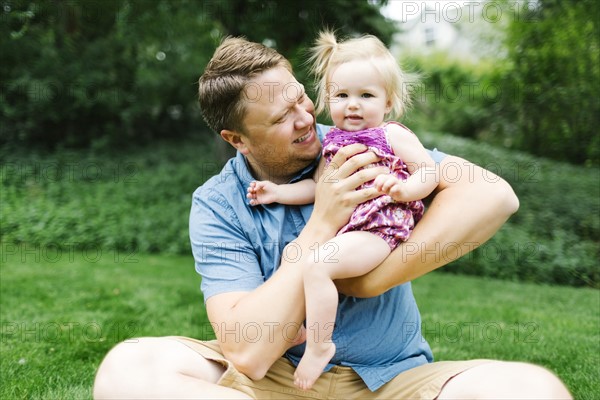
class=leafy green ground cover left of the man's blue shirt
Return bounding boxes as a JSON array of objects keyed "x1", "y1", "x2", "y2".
[{"x1": 0, "y1": 140, "x2": 219, "y2": 254}]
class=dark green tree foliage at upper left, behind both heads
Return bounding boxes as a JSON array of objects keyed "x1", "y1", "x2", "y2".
[{"x1": 0, "y1": 0, "x2": 393, "y2": 148}]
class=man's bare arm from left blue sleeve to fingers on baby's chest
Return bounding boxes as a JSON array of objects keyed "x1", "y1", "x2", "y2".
[{"x1": 206, "y1": 145, "x2": 383, "y2": 379}]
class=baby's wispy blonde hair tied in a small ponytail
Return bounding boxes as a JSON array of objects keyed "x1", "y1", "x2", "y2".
[{"x1": 310, "y1": 30, "x2": 411, "y2": 118}]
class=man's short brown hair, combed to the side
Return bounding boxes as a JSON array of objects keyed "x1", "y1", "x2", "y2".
[{"x1": 198, "y1": 37, "x2": 292, "y2": 133}]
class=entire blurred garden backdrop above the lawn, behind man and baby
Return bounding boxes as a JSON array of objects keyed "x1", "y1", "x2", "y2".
[{"x1": 0, "y1": 0, "x2": 600, "y2": 287}]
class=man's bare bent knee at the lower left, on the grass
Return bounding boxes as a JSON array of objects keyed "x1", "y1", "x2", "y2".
[{"x1": 94, "y1": 338, "x2": 250, "y2": 399}]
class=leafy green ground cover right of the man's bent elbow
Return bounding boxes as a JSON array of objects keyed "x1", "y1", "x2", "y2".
[{"x1": 419, "y1": 133, "x2": 600, "y2": 287}]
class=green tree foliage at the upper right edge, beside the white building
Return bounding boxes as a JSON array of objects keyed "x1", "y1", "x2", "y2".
[{"x1": 505, "y1": 0, "x2": 600, "y2": 164}]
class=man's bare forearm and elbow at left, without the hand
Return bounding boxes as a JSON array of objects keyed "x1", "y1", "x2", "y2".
[{"x1": 207, "y1": 217, "x2": 335, "y2": 380}]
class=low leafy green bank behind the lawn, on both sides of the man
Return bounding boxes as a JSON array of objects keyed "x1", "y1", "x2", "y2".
[{"x1": 0, "y1": 137, "x2": 600, "y2": 287}]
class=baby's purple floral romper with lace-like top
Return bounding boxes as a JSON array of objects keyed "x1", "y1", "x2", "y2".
[{"x1": 323, "y1": 122, "x2": 424, "y2": 250}]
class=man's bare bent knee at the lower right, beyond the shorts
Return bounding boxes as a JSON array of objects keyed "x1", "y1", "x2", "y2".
[{"x1": 438, "y1": 361, "x2": 572, "y2": 400}]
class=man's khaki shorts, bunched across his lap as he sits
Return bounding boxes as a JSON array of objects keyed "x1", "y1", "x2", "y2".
[{"x1": 172, "y1": 337, "x2": 490, "y2": 400}]
